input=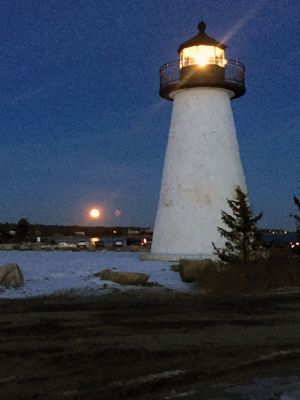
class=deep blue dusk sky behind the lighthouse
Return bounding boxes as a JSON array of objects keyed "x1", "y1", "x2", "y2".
[{"x1": 0, "y1": 0, "x2": 300, "y2": 229}]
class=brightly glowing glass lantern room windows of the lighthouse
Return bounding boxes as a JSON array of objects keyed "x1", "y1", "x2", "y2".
[{"x1": 180, "y1": 45, "x2": 226, "y2": 68}]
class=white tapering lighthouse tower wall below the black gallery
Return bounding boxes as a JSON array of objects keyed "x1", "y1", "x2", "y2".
[{"x1": 147, "y1": 87, "x2": 246, "y2": 261}]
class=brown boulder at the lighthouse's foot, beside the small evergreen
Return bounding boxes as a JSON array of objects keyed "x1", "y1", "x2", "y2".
[{"x1": 179, "y1": 258, "x2": 216, "y2": 283}]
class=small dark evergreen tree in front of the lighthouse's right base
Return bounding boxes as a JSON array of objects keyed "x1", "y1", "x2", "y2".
[{"x1": 213, "y1": 187, "x2": 262, "y2": 263}]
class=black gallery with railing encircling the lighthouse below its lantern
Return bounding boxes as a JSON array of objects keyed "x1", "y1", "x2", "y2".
[{"x1": 159, "y1": 60, "x2": 245, "y2": 98}]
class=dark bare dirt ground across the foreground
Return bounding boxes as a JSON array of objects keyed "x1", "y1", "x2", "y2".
[{"x1": 0, "y1": 288, "x2": 300, "y2": 400}]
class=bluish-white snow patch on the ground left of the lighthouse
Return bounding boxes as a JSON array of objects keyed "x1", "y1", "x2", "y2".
[{"x1": 0, "y1": 250, "x2": 190, "y2": 298}]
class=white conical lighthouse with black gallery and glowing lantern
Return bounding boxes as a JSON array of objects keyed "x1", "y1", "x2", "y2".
[{"x1": 147, "y1": 21, "x2": 246, "y2": 261}]
